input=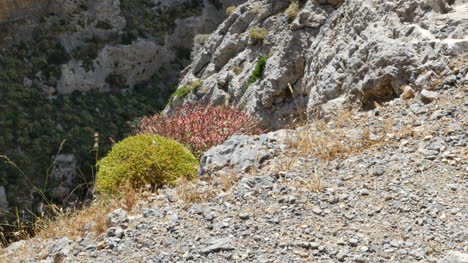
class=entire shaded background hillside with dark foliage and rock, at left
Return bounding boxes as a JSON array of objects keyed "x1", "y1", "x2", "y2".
[{"x1": 0, "y1": 0, "x2": 244, "y2": 227}]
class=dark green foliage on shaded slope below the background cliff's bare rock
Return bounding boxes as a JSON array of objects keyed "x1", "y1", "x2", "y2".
[{"x1": 0, "y1": 49, "x2": 170, "y2": 196}]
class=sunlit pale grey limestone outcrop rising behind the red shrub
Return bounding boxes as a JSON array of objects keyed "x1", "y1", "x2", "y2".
[{"x1": 170, "y1": 0, "x2": 468, "y2": 128}]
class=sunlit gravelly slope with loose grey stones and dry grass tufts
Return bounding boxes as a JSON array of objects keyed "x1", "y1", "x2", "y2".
[{"x1": 1, "y1": 64, "x2": 468, "y2": 263}]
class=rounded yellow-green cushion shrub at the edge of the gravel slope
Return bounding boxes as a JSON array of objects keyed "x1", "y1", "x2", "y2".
[{"x1": 95, "y1": 135, "x2": 199, "y2": 193}]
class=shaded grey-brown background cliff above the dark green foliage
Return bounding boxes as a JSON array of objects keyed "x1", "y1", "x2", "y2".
[{"x1": 0, "y1": 0, "x2": 246, "y2": 95}]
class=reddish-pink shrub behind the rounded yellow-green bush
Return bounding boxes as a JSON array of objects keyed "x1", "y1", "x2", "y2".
[{"x1": 135, "y1": 104, "x2": 262, "y2": 156}]
